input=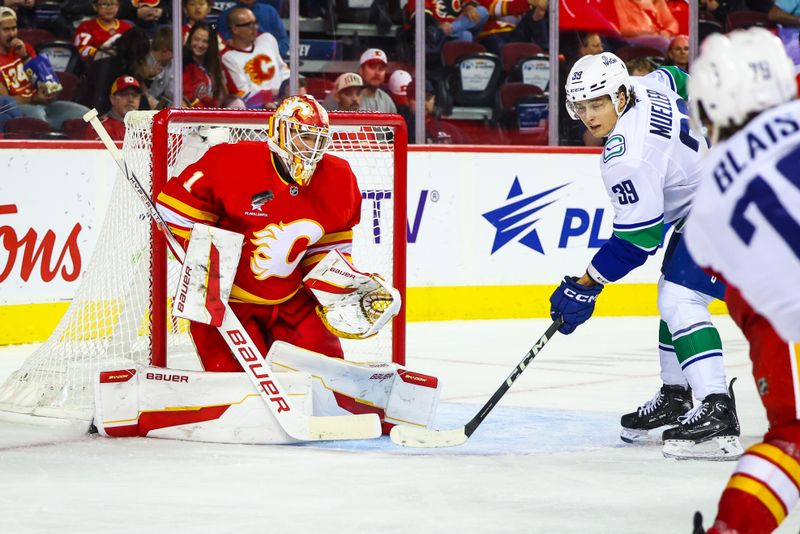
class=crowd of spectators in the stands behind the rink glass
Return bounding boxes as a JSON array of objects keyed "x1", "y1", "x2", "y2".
[{"x1": 0, "y1": 0, "x2": 800, "y2": 145}]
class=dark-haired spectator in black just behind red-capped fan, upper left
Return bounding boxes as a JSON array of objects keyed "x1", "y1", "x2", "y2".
[{"x1": 81, "y1": 27, "x2": 152, "y2": 115}]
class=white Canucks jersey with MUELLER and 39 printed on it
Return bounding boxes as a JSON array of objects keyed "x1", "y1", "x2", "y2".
[{"x1": 601, "y1": 74, "x2": 706, "y2": 252}]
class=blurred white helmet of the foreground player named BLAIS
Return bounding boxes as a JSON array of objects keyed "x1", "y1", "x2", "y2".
[{"x1": 687, "y1": 27, "x2": 797, "y2": 144}]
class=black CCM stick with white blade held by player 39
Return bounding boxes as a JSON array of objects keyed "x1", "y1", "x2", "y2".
[{"x1": 389, "y1": 317, "x2": 564, "y2": 448}]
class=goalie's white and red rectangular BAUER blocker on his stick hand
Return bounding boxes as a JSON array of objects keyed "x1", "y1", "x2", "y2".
[{"x1": 172, "y1": 223, "x2": 244, "y2": 326}]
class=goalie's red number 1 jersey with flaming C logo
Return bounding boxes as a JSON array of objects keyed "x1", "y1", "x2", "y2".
[{"x1": 157, "y1": 141, "x2": 361, "y2": 304}]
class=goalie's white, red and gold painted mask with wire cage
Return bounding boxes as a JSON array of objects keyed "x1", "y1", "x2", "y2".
[{"x1": 268, "y1": 95, "x2": 333, "y2": 185}]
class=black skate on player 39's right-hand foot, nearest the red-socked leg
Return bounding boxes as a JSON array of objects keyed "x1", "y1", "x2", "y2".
[{"x1": 663, "y1": 378, "x2": 744, "y2": 460}]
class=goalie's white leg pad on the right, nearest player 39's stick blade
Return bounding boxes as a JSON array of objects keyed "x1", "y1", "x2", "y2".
[{"x1": 267, "y1": 341, "x2": 441, "y2": 428}]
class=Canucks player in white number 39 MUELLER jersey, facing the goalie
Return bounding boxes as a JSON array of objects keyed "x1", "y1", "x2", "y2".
[{"x1": 550, "y1": 52, "x2": 742, "y2": 460}]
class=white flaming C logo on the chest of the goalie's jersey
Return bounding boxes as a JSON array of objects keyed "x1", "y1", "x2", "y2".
[{"x1": 250, "y1": 219, "x2": 325, "y2": 280}]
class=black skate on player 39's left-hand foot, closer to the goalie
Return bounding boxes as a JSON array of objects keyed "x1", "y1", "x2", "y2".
[{"x1": 619, "y1": 384, "x2": 692, "y2": 443}]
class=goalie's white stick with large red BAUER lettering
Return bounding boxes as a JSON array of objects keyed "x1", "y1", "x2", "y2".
[{"x1": 83, "y1": 109, "x2": 381, "y2": 441}]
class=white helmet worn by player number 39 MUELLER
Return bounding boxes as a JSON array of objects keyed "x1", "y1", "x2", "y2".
[{"x1": 564, "y1": 52, "x2": 631, "y2": 120}]
